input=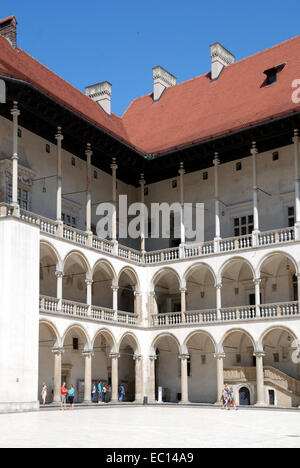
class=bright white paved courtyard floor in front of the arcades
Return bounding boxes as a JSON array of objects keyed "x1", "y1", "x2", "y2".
[{"x1": 0, "y1": 407, "x2": 300, "y2": 448}]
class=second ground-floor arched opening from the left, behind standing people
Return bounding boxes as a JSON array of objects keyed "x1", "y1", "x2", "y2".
[{"x1": 61, "y1": 326, "x2": 88, "y2": 403}]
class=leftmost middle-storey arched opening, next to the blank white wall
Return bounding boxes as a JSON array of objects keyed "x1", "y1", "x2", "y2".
[{"x1": 40, "y1": 243, "x2": 59, "y2": 297}]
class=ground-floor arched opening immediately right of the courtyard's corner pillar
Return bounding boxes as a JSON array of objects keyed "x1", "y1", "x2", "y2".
[{"x1": 153, "y1": 335, "x2": 181, "y2": 402}]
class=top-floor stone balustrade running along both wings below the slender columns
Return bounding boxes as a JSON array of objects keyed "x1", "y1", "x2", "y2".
[{"x1": 0, "y1": 203, "x2": 295, "y2": 265}]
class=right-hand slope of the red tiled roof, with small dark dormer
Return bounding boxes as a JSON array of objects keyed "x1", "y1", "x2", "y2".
[{"x1": 122, "y1": 36, "x2": 300, "y2": 153}]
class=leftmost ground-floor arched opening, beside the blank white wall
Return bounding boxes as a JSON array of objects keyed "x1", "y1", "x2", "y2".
[{"x1": 38, "y1": 322, "x2": 57, "y2": 404}]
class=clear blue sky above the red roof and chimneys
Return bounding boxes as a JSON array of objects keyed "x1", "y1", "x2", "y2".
[{"x1": 0, "y1": 0, "x2": 300, "y2": 115}]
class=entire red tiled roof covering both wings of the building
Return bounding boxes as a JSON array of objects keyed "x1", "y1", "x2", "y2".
[{"x1": 0, "y1": 30, "x2": 300, "y2": 154}]
